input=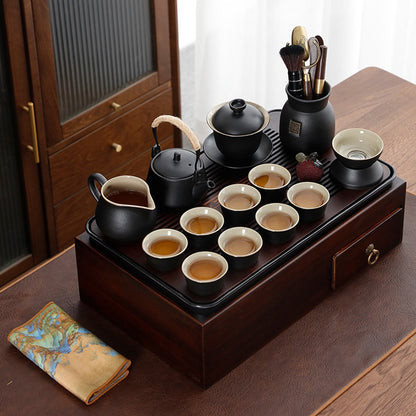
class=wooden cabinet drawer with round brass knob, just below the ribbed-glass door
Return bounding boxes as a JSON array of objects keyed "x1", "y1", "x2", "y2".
[{"x1": 49, "y1": 91, "x2": 173, "y2": 204}]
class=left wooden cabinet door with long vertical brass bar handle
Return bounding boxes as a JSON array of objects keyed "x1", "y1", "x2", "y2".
[{"x1": 0, "y1": 0, "x2": 48, "y2": 285}]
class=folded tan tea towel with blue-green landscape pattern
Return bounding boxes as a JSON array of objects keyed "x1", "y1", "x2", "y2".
[{"x1": 8, "y1": 302, "x2": 131, "y2": 404}]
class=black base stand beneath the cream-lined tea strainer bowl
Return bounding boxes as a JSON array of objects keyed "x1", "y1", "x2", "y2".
[{"x1": 330, "y1": 159, "x2": 383, "y2": 189}]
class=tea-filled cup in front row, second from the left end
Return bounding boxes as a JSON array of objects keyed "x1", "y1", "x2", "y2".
[{"x1": 218, "y1": 227, "x2": 263, "y2": 269}]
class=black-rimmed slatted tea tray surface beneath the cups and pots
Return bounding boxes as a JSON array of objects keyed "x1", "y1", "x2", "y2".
[{"x1": 86, "y1": 110, "x2": 395, "y2": 316}]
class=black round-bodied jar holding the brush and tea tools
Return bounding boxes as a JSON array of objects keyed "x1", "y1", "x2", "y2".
[{"x1": 280, "y1": 82, "x2": 335, "y2": 154}]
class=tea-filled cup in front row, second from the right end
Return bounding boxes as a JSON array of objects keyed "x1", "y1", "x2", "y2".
[{"x1": 256, "y1": 203, "x2": 299, "y2": 244}]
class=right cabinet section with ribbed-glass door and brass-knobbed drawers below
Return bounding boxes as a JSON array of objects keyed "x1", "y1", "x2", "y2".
[{"x1": 26, "y1": 0, "x2": 180, "y2": 252}]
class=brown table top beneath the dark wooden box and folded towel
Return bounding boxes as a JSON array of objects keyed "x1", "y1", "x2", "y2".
[{"x1": 0, "y1": 68, "x2": 416, "y2": 416}]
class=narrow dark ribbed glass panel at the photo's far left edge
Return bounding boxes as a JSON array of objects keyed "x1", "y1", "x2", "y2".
[{"x1": 0, "y1": 8, "x2": 30, "y2": 271}]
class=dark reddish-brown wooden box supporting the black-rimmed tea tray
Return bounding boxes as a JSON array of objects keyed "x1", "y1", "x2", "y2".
[{"x1": 75, "y1": 178, "x2": 406, "y2": 388}]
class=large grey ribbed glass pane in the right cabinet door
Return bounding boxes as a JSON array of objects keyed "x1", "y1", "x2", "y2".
[{"x1": 49, "y1": 0, "x2": 155, "y2": 122}]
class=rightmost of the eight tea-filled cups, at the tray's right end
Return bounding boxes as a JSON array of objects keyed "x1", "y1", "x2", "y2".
[{"x1": 287, "y1": 182, "x2": 330, "y2": 222}]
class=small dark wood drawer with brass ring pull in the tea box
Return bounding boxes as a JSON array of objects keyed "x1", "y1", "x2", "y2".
[{"x1": 331, "y1": 208, "x2": 404, "y2": 290}]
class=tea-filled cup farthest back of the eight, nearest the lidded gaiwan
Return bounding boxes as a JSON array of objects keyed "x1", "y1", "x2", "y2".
[{"x1": 248, "y1": 163, "x2": 292, "y2": 202}]
